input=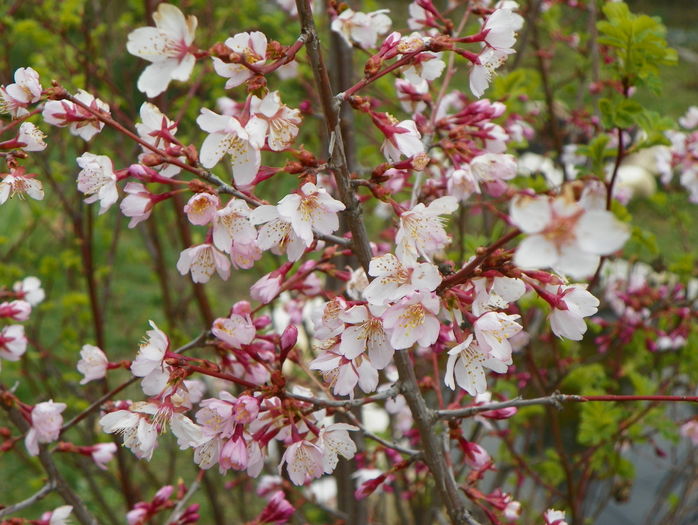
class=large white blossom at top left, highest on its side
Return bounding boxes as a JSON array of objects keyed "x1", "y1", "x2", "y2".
[{"x1": 126, "y1": 3, "x2": 197, "y2": 98}]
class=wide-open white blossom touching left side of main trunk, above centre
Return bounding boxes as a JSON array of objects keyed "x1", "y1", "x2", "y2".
[{"x1": 276, "y1": 182, "x2": 345, "y2": 246}]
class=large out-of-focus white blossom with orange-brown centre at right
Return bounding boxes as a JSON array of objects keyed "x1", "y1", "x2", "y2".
[{"x1": 511, "y1": 195, "x2": 630, "y2": 279}]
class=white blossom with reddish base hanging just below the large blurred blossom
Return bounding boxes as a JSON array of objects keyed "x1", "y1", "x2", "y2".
[{"x1": 550, "y1": 284, "x2": 599, "y2": 341}]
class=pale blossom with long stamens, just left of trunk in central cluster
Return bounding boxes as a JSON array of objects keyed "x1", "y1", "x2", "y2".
[{"x1": 339, "y1": 305, "x2": 394, "y2": 370}]
